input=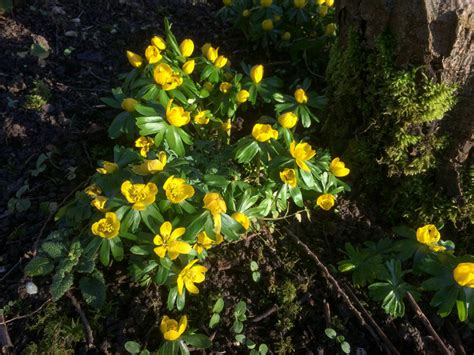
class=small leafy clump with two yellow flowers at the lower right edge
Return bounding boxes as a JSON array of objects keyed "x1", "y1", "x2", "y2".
[{"x1": 339, "y1": 224, "x2": 474, "y2": 328}]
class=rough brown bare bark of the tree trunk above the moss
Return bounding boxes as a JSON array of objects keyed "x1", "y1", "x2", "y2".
[{"x1": 336, "y1": 0, "x2": 474, "y2": 197}]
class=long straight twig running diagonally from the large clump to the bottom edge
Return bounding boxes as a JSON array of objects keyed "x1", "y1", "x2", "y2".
[{"x1": 284, "y1": 227, "x2": 400, "y2": 355}]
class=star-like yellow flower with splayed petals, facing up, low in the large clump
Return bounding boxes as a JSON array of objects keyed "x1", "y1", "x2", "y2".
[{"x1": 153, "y1": 222, "x2": 192, "y2": 260}]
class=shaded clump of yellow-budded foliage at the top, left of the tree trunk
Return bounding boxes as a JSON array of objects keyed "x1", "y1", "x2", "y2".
[{"x1": 217, "y1": 0, "x2": 337, "y2": 67}]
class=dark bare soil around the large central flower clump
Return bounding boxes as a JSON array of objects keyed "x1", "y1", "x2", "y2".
[{"x1": 0, "y1": 0, "x2": 470, "y2": 354}]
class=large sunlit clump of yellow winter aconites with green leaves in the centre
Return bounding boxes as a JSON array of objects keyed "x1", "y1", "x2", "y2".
[{"x1": 27, "y1": 21, "x2": 349, "y2": 354}]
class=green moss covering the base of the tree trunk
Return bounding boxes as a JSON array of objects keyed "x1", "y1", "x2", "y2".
[{"x1": 321, "y1": 31, "x2": 473, "y2": 231}]
